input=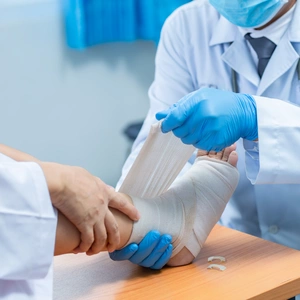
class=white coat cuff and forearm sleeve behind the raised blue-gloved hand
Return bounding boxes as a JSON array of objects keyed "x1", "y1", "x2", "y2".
[{"x1": 244, "y1": 96, "x2": 300, "y2": 184}]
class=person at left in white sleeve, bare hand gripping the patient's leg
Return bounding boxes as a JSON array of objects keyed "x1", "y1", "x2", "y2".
[{"x1": 0, "y1": 145, "x2": 138, "y2": 300}]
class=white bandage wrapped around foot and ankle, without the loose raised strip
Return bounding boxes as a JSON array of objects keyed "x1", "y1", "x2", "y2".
[{"x1": 124, "y1": 156, "x2": 239, "y2": 257}]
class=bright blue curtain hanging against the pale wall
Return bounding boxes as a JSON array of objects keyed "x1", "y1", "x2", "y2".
[{"x1": 64, "y1": 0, "x2": 191, "y2": 49}]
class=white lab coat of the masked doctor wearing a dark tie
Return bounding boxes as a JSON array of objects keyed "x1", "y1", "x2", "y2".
[{"x1": 118, "y1": 0, "x2": 300, "y2": 249}]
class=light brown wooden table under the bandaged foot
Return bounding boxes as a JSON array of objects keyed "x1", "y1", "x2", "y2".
[{"x1": 54, "y1": 225, "x2": 300, "y2": 300}]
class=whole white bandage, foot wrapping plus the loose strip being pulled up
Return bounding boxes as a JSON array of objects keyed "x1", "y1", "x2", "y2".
[{"x1": 119, "y1": 123, "x2": 238, "y2": 257}]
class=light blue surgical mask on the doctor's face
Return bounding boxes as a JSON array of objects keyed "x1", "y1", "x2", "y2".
[{"x1": 209, "y1": 0, "x2": 288, "y2": 28}]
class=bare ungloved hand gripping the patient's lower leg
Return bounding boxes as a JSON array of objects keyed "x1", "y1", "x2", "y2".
[{"x1": 39, "y1": 162, "x2": 139, "y2": 255}]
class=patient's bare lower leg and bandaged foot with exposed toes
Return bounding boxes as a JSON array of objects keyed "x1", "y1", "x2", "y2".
[{"x1": 55, "y1": 146, "x2": 239, "y2": 266}]
